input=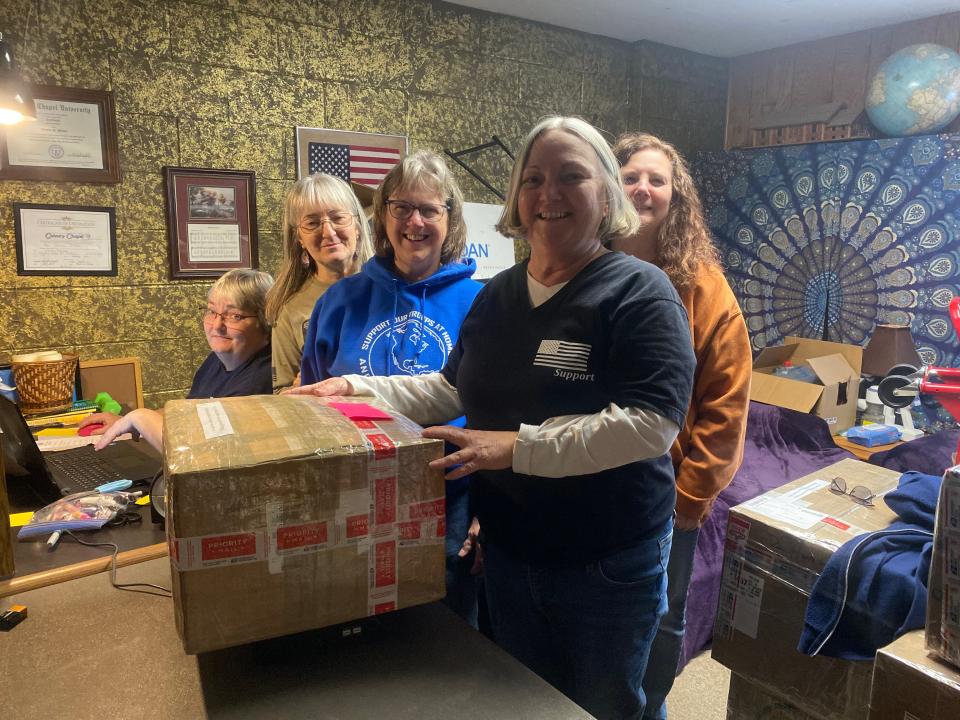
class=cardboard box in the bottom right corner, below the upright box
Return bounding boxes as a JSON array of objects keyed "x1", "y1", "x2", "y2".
[{"x1": 870, "y1": 630, "x2": 960, "y2": 720}]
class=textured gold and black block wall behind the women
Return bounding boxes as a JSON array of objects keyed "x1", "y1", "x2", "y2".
[{"x1": 0, "y1": 0, "x2": 727, "y2": 406}]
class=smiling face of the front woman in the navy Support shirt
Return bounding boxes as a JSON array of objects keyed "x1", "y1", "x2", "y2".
[{"x1": 517, "y1": 130, "x2": 607, "y2": 255}]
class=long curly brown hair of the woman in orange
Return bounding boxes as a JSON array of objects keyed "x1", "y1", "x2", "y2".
[{"x1": 613, "y1": 132, "x2": 720, "y2": 289}]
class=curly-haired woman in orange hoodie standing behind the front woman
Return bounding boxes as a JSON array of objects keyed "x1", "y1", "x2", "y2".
[{"x1": 613, "y1": 133, "x2": 752, "y2": 718}]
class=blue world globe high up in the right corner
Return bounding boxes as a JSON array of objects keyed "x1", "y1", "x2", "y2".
[{"x1": 867, "y1": 43, "x2": 960, "y2": 137}]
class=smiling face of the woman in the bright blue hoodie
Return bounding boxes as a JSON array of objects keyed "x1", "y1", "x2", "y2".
[{"x1": 383, "y1": 188, "x2": 449, "y2": 282}]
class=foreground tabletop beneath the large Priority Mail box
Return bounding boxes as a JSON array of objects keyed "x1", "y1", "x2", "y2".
[{"x1": 0, "y1": 559, "x2": 590, "y2": 720}]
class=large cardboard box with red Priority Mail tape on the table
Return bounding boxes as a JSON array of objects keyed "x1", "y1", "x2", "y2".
[{"x1": 164, "y1": 396, "x2": 445, "y2": 653}]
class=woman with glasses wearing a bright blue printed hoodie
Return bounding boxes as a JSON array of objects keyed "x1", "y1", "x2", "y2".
[{"x1": 300, "y1": 151, "x2": 482, "y2": 626}]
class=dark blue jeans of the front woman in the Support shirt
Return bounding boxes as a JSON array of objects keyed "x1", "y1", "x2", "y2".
[{"x1": 483, "y1": 521, "x2": 673, "y2": 720}]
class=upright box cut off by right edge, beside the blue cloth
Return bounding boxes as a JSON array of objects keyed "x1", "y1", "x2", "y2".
[{"x1": 926, "y1": 466, "x2": 960, "y2": 668}]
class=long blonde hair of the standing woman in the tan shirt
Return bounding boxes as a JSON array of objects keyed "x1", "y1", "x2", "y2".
[{"x1": 267, "y1": 173, "x2": 373, "y2": 325}]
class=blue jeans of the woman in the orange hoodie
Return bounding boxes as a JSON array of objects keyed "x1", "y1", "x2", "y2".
[{"x1": 643, "y1": 528, "x2": 700, "y2": 720}]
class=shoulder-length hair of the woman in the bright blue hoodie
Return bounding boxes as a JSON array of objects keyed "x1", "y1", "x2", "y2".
[{"x1": 373, "y1": 150, "x2": 467, "y2": 265}]
